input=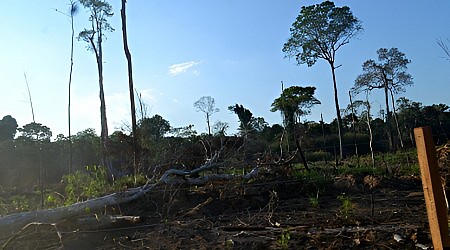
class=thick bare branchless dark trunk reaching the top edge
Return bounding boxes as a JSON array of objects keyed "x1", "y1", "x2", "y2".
[{"x1": 120, "y1": 0, "x2": 139, "y2": 175}]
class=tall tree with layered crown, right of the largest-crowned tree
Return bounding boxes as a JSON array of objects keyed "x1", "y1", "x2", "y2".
[{"x1": 352, "y1": 48, "x2": 413, "y2": 150}]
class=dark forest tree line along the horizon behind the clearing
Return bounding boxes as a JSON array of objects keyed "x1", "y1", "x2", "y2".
[{"x1": 0, "y1": 95, "x2": 450, "y2": 188}]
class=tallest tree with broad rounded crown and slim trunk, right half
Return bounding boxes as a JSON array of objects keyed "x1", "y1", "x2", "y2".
[{"x1": 283, "y1": 1, "x2": 363, "y2": 158}]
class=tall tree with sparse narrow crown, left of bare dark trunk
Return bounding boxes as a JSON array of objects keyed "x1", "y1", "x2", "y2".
[{"x1": 78, "y1": 0, "x2": 114, "y2": 176}]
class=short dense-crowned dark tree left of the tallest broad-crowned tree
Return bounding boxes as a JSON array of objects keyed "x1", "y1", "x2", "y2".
[{"x1": 270, "y1": 86, "x2": 320, "y2": 170}]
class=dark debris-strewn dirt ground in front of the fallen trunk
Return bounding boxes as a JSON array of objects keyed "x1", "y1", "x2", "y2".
[{"x1": 1, "y1": 175, "x2": 431, "y2": 249}]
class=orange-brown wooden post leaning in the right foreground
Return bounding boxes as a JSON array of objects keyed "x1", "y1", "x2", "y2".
[{"x1": 414, "y1": 127, "x2": 450, "y2": 249}]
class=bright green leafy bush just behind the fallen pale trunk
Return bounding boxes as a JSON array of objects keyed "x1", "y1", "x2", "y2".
[{"x1": 63, "y1": 166, "x2": 111, "y2": 205}]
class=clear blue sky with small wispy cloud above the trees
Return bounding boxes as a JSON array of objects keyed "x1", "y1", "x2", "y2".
[{"x1": 0, "y1": 0, "x2": 450, "y2": 136}]
